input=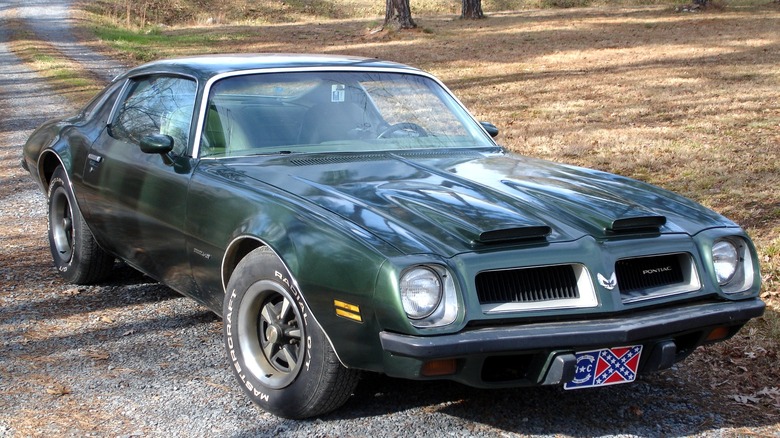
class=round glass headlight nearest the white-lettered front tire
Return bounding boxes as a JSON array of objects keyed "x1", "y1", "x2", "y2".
[{"x1": 400, "y1": 267, "x2": 443, "y2": 319}]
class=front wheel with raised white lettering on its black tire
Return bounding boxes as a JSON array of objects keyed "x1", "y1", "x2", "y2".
[{"x1": 223, "y1": 247, "x2": 359, "y2": 419}]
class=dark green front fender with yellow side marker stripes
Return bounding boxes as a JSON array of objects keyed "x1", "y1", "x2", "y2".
[{"x1": 186, "y1": 162, "x2": 398, "y2": 370}]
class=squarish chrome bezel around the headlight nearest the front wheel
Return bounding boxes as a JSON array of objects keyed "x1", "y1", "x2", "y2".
[{"x1": 398, "y1": 265, "x2": 459, "y2": 328}]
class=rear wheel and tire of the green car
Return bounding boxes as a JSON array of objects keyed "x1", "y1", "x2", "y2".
[{"x1": 48, "y1": 166, "x2": 114, "y2": 284}]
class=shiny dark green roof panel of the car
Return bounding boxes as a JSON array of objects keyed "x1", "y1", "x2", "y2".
[{"x1": 122, "y1": 53, "x2": 420, "y2": 79}]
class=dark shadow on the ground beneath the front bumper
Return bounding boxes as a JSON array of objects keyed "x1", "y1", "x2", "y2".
[{"x1": 314, "y1": 346, "x2": 775, "y2": 436}]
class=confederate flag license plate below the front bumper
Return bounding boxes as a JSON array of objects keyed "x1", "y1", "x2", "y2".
[{"x1": 563, "y1": 345, "x2": 642, "y2": 389}]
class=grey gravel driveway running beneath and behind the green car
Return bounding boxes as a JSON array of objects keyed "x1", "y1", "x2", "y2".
[{"x1": 0, "y1": 0, "x2": 778, "y2": 437}]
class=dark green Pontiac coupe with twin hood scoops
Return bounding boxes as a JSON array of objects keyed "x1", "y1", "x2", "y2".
[{"x1": 22, "y1": 55, "x2": 764, "y2": 418}]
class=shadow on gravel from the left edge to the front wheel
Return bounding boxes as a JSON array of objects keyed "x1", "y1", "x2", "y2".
[{"x1": 0, "y1": 256, "x2": 219, "y2": 356}]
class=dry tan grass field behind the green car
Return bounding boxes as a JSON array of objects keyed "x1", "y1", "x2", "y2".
[{"x1": 84, "y1": 3, "x2": 780, "y2": 297}]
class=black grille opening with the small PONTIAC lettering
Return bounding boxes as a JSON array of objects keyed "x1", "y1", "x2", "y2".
[{"x1": 615, "y1": 254, "x2": 691, "y2": 301}]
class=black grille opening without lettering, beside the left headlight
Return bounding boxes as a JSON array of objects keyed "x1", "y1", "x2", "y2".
[{"x1": 476, "y1": 265, "x2": 579, "y2": 304}]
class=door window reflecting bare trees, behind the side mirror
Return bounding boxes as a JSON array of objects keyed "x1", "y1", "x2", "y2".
[{"x1": 111, "y1": 76, "x2": 196, "y2": 155}]
